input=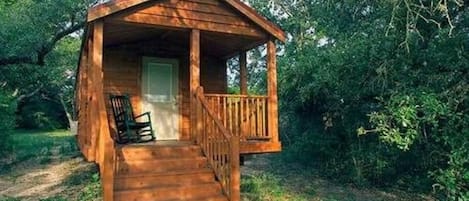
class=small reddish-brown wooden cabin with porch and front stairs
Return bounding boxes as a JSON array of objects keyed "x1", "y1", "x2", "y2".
[{"x1": 76, "y1": 0, "x2": 286, "y2": 201}]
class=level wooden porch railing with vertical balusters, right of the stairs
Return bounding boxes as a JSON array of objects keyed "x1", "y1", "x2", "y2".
[{"x1": 205, "y1": 94, "x2": 272, "y2": 141}]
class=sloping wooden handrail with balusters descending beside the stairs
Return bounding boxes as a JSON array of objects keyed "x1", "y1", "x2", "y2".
[{"x1": 192, "y1": 87, "x2": 240, "y2": 201}]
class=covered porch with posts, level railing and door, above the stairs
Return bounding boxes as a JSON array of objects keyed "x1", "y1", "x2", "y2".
[{"x1": 88, "y1": 12, "x2": 281, "y2": 154}]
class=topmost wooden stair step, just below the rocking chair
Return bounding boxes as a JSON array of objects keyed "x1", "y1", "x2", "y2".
[{"x1": 117, "y1": 145, "x2": 203, "y2": 161}]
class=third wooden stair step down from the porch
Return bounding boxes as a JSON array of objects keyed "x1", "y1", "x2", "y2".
[{"x1": 114, "y1": 168, "x2": 215, "y2": 190}]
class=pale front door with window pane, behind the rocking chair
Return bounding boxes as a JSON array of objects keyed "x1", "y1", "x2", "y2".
[{"x1": 142, "y1": 57, "x2": 179, "y2": 140}]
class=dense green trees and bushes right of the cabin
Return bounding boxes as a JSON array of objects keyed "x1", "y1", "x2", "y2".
[{"x1": 249, "y1": 0, "x2": 469, "y2": 200}]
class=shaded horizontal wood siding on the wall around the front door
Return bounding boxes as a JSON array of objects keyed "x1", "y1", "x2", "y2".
[{"x1": 103, "y1": 48, "x2": 227, "y2": 140}]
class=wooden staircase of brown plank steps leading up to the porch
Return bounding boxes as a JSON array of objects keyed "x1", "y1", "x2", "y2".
[{"x1": 114, "y1": 143, "x2": 228, "y2": 201}]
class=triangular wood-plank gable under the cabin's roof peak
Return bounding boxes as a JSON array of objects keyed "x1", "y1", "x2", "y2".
[{"x1": 107, "y1": 0, "x2": 266, "y2": 38}]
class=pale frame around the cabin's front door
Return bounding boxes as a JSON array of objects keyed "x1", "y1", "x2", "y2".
[{"x1": 139, "y1": 56, "x2": 183, "y2": 140}]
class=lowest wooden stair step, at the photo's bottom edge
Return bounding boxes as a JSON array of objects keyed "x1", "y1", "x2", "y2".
[{"x1": 114, "y1": 182, "x2": 223, "y2": 201}]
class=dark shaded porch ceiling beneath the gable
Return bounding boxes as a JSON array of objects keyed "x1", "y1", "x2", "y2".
[{"x1": 104, "y1": 22, "x2": 265, "y2": 58}]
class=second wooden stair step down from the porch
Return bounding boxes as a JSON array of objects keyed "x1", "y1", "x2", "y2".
[{"x1": 117, "y1": 157, "x2": 208, "y2": 174}]
